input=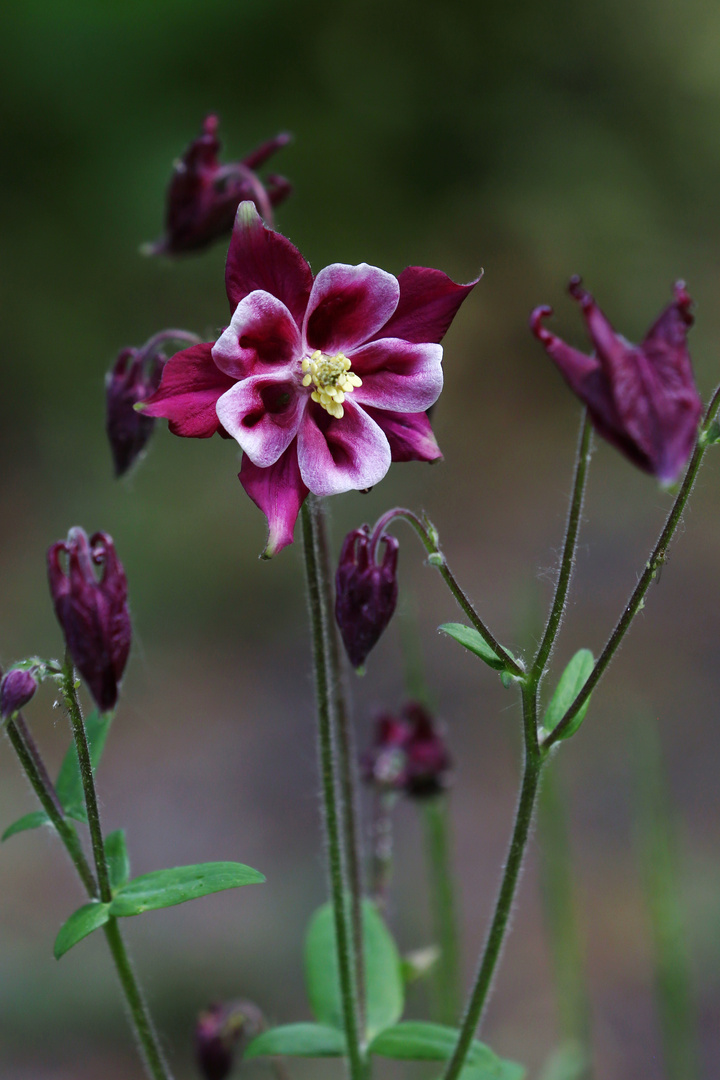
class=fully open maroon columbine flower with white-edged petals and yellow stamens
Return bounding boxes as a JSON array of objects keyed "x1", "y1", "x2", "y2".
[{"x1": 144, "y1": 202, "x2": 476, "y2": 555}]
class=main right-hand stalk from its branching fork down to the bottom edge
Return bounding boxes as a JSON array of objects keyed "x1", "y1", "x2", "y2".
[{"x1": 443, "y1": 686, "x2": 543, "y2": 1080}]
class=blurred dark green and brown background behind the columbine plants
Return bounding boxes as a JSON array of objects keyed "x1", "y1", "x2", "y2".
[{"x1": 0, "y1": 0, "x2": 720, "y2": 1080}]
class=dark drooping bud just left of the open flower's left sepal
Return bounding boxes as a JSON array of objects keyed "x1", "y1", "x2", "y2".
[{"x1": 105, "y1": 347, "x2": 165, "y2": 476}]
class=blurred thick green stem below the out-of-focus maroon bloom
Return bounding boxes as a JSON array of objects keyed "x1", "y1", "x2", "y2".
[{"x1": 423, "y1": 795, "x2": 461, "y2": 1025}]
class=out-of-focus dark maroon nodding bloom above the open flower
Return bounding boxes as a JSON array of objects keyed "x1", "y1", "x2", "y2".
[{"x1": 146, "y1": 116, "x2": 293, "y2": 255}]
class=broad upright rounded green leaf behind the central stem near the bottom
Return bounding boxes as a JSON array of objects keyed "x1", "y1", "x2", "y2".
[{"x1": 305, "y1": 900, "x2": 405, "y2": 1040}]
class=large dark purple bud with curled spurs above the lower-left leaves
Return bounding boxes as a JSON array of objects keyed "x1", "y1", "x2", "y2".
[{"x1": 47, "y1": 528, "x2": 132, "y2": 713}]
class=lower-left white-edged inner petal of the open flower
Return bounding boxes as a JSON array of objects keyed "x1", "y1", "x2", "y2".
[{"x1": 217, "y1": 375, "x2": 307, "y2": 469}]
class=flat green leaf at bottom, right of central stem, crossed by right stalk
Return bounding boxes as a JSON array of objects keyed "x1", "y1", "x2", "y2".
[{"x1": 368, "y1": 1021, "x2": 525, "y2": 1080}]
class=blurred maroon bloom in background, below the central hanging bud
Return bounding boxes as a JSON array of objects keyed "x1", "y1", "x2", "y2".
[{"x1": 361, "y1": 701, "x2": 451, "y2": 799}]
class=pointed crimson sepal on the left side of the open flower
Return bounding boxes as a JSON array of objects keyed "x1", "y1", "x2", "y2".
[{"x1": 142, "y1": 341, "x2": 235, "y2": 438}]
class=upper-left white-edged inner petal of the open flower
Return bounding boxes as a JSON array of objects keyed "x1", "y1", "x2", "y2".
[{"x1": 213, "y1": 289, "x2": 301, "y2": 379}]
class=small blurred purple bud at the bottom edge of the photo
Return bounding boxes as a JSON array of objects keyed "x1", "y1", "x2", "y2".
[{"x1": 195, "y1": 1001, "x2": 264, "y2": 1080}]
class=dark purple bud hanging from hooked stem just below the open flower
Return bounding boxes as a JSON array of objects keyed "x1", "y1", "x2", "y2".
[{"x1": 335, "y1": 525, "x2": 398, "y2": 667}]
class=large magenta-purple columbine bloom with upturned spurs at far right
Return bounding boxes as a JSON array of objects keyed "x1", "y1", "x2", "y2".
[{"x1": 530, "y1": 278, "x2": 702, "y2": 483}]
